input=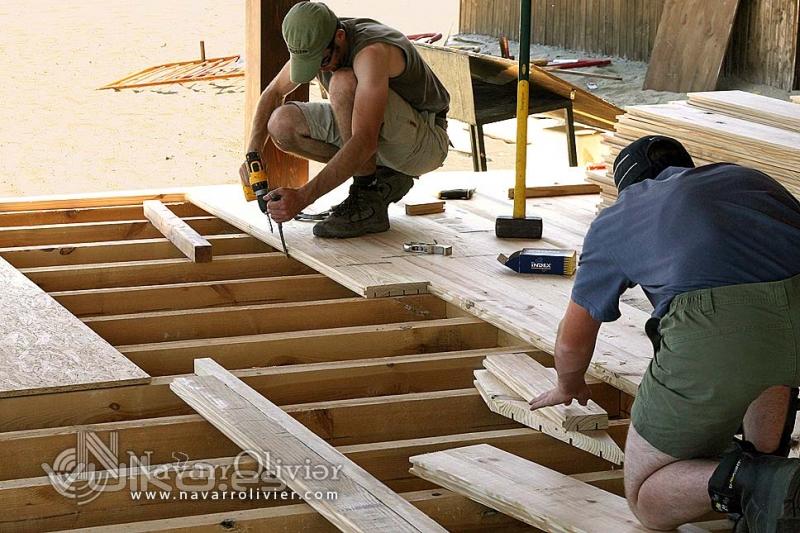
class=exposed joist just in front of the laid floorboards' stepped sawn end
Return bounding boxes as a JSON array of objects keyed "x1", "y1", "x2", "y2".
[{"x1": 84, "y1": 295, "x2": 446, "y2": 345}]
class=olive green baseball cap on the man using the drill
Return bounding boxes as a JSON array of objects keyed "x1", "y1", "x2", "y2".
[{"x1": 282, "y1": 2, "x2": 339, "y2": 83}]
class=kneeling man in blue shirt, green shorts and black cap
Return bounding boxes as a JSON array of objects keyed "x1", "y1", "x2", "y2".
[{"x1": 531, "y1": 136, "x2": 800, "y2": 532}]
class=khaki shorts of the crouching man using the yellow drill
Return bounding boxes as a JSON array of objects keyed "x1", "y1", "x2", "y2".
[{"x1": 290, "y1": 89, "x2": 448, "y2": 176}]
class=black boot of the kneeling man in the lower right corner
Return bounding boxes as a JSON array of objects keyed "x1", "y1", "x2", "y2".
[{"x1": 708, "y1": 442, "x2": 800, "y2": 533}]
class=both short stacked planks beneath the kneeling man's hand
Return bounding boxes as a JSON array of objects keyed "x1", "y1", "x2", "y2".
[{"x1": 474, "y1": 353, "x2": 624, "y2": 464}]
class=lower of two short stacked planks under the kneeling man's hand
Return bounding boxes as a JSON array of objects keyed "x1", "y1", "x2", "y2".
[{"x1": 475, "y1": 370, "x2": 625, "y2": 465}]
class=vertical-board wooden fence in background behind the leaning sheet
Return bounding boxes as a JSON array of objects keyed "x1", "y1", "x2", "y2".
[{"x1": 460, "y1": 0, "x2": 800, "y2": 90}]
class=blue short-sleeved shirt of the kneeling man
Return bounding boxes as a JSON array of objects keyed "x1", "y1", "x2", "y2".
[{"x1": 572, "y1": 163, "x2": 800, "y2": 322}]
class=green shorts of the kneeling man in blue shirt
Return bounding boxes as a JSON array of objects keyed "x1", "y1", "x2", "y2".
[{"x1": 631, "y1": 276, "x2": 800, "y2": 459}]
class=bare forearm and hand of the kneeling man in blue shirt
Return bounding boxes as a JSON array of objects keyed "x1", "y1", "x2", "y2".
[{"x1": 530, "y1": 300, "x2": 601, "y2": 410}]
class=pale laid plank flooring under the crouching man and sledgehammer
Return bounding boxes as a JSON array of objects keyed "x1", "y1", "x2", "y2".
[{"x1": 190, "y1": 171, "x2": 652, "y2": 394}]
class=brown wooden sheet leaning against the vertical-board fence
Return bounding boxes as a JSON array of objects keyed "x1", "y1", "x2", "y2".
[{"x1": 644, "y1": 0, "x2": 739, "y2": 93}]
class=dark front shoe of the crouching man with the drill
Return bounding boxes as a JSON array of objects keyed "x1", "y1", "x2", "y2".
[{"x1": 313, "y1": 184, "x2": 389, "y2": 239}]
